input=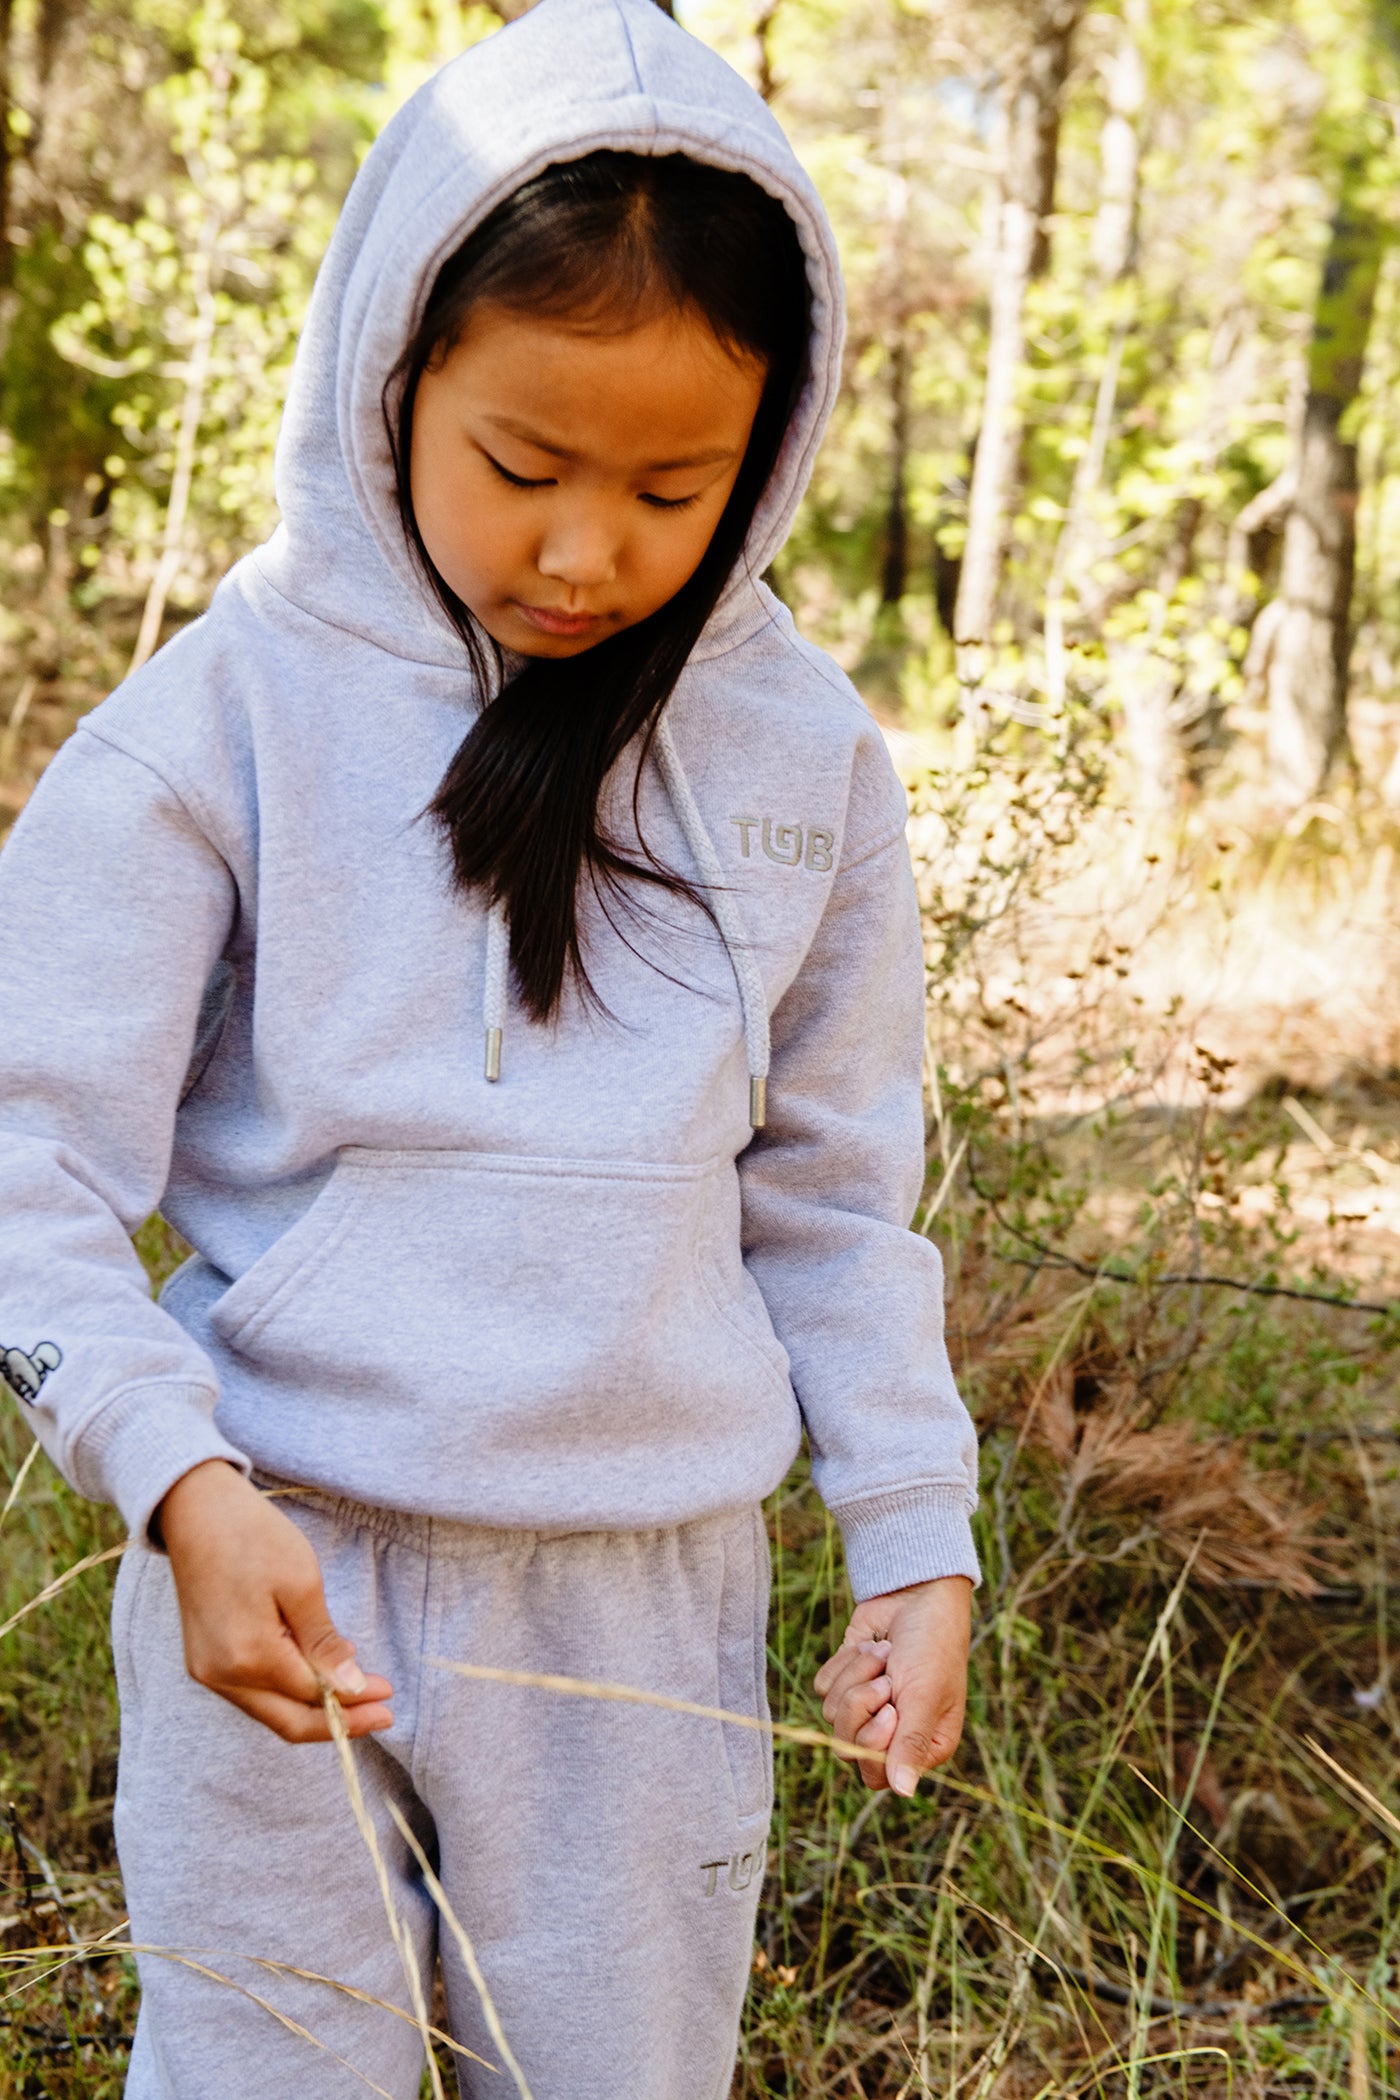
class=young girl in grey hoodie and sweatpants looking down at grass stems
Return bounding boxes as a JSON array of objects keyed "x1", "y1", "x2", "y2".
[{"x1": 0, "y1": 0, "x2": 976, "y2": 2100}]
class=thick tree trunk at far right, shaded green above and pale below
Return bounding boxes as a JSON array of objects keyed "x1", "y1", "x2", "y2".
[{"x1": 1268, "y1": 153, "x2": 1385, "y2": 804}]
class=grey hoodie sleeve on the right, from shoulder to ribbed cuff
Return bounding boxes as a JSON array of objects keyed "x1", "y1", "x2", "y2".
[{"x1": 739, "y1": 734, "x2": 978, "y2": 1600}]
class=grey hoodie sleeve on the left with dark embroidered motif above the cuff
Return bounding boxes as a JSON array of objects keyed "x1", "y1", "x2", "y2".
[{"x1": 0, "y1": 729, "x2": 246, "y2": 1537}]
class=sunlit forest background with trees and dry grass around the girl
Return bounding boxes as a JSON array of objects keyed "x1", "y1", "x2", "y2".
[{"x1": 0, "y1": 0, "x2": 1400, "y2": 2100}]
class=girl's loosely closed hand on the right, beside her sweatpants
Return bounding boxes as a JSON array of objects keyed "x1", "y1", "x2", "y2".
[{"x1": 816, "y1": 1575, "x2": 972, "y2": 1793}]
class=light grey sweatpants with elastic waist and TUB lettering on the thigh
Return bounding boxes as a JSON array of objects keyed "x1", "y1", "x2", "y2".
[{"x1": 113, "y1": 1495, "x2": 772, "y2": 2100}]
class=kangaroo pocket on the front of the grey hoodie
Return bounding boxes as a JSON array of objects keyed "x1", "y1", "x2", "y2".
[{"x1": 210, "y1": 1149, "x2": 791, "y2": 1466}]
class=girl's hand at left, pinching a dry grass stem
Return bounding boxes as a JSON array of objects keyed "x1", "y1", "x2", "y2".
[{"x1": 155, "y1": 1460, "x2": 395, "y2": 1743}]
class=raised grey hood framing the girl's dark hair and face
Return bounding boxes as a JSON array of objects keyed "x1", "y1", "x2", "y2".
[{"x1": 254, "y1": 0, "x2": 842, "y2": 666}]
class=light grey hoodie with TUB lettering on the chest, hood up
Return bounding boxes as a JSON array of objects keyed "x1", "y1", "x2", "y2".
[{"x1": 0, "y1": 0, "x2": 976, "y2": 1596}]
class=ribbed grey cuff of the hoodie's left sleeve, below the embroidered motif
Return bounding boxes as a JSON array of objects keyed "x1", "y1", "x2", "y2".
[{"x1": 73, "y1": 1382, "x2": 250, "y2": 1546}]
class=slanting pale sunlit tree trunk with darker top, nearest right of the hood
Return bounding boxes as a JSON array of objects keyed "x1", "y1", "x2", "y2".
[{"x1": 953, "y1": 0, "x2": 1083, "y2": 727}]
